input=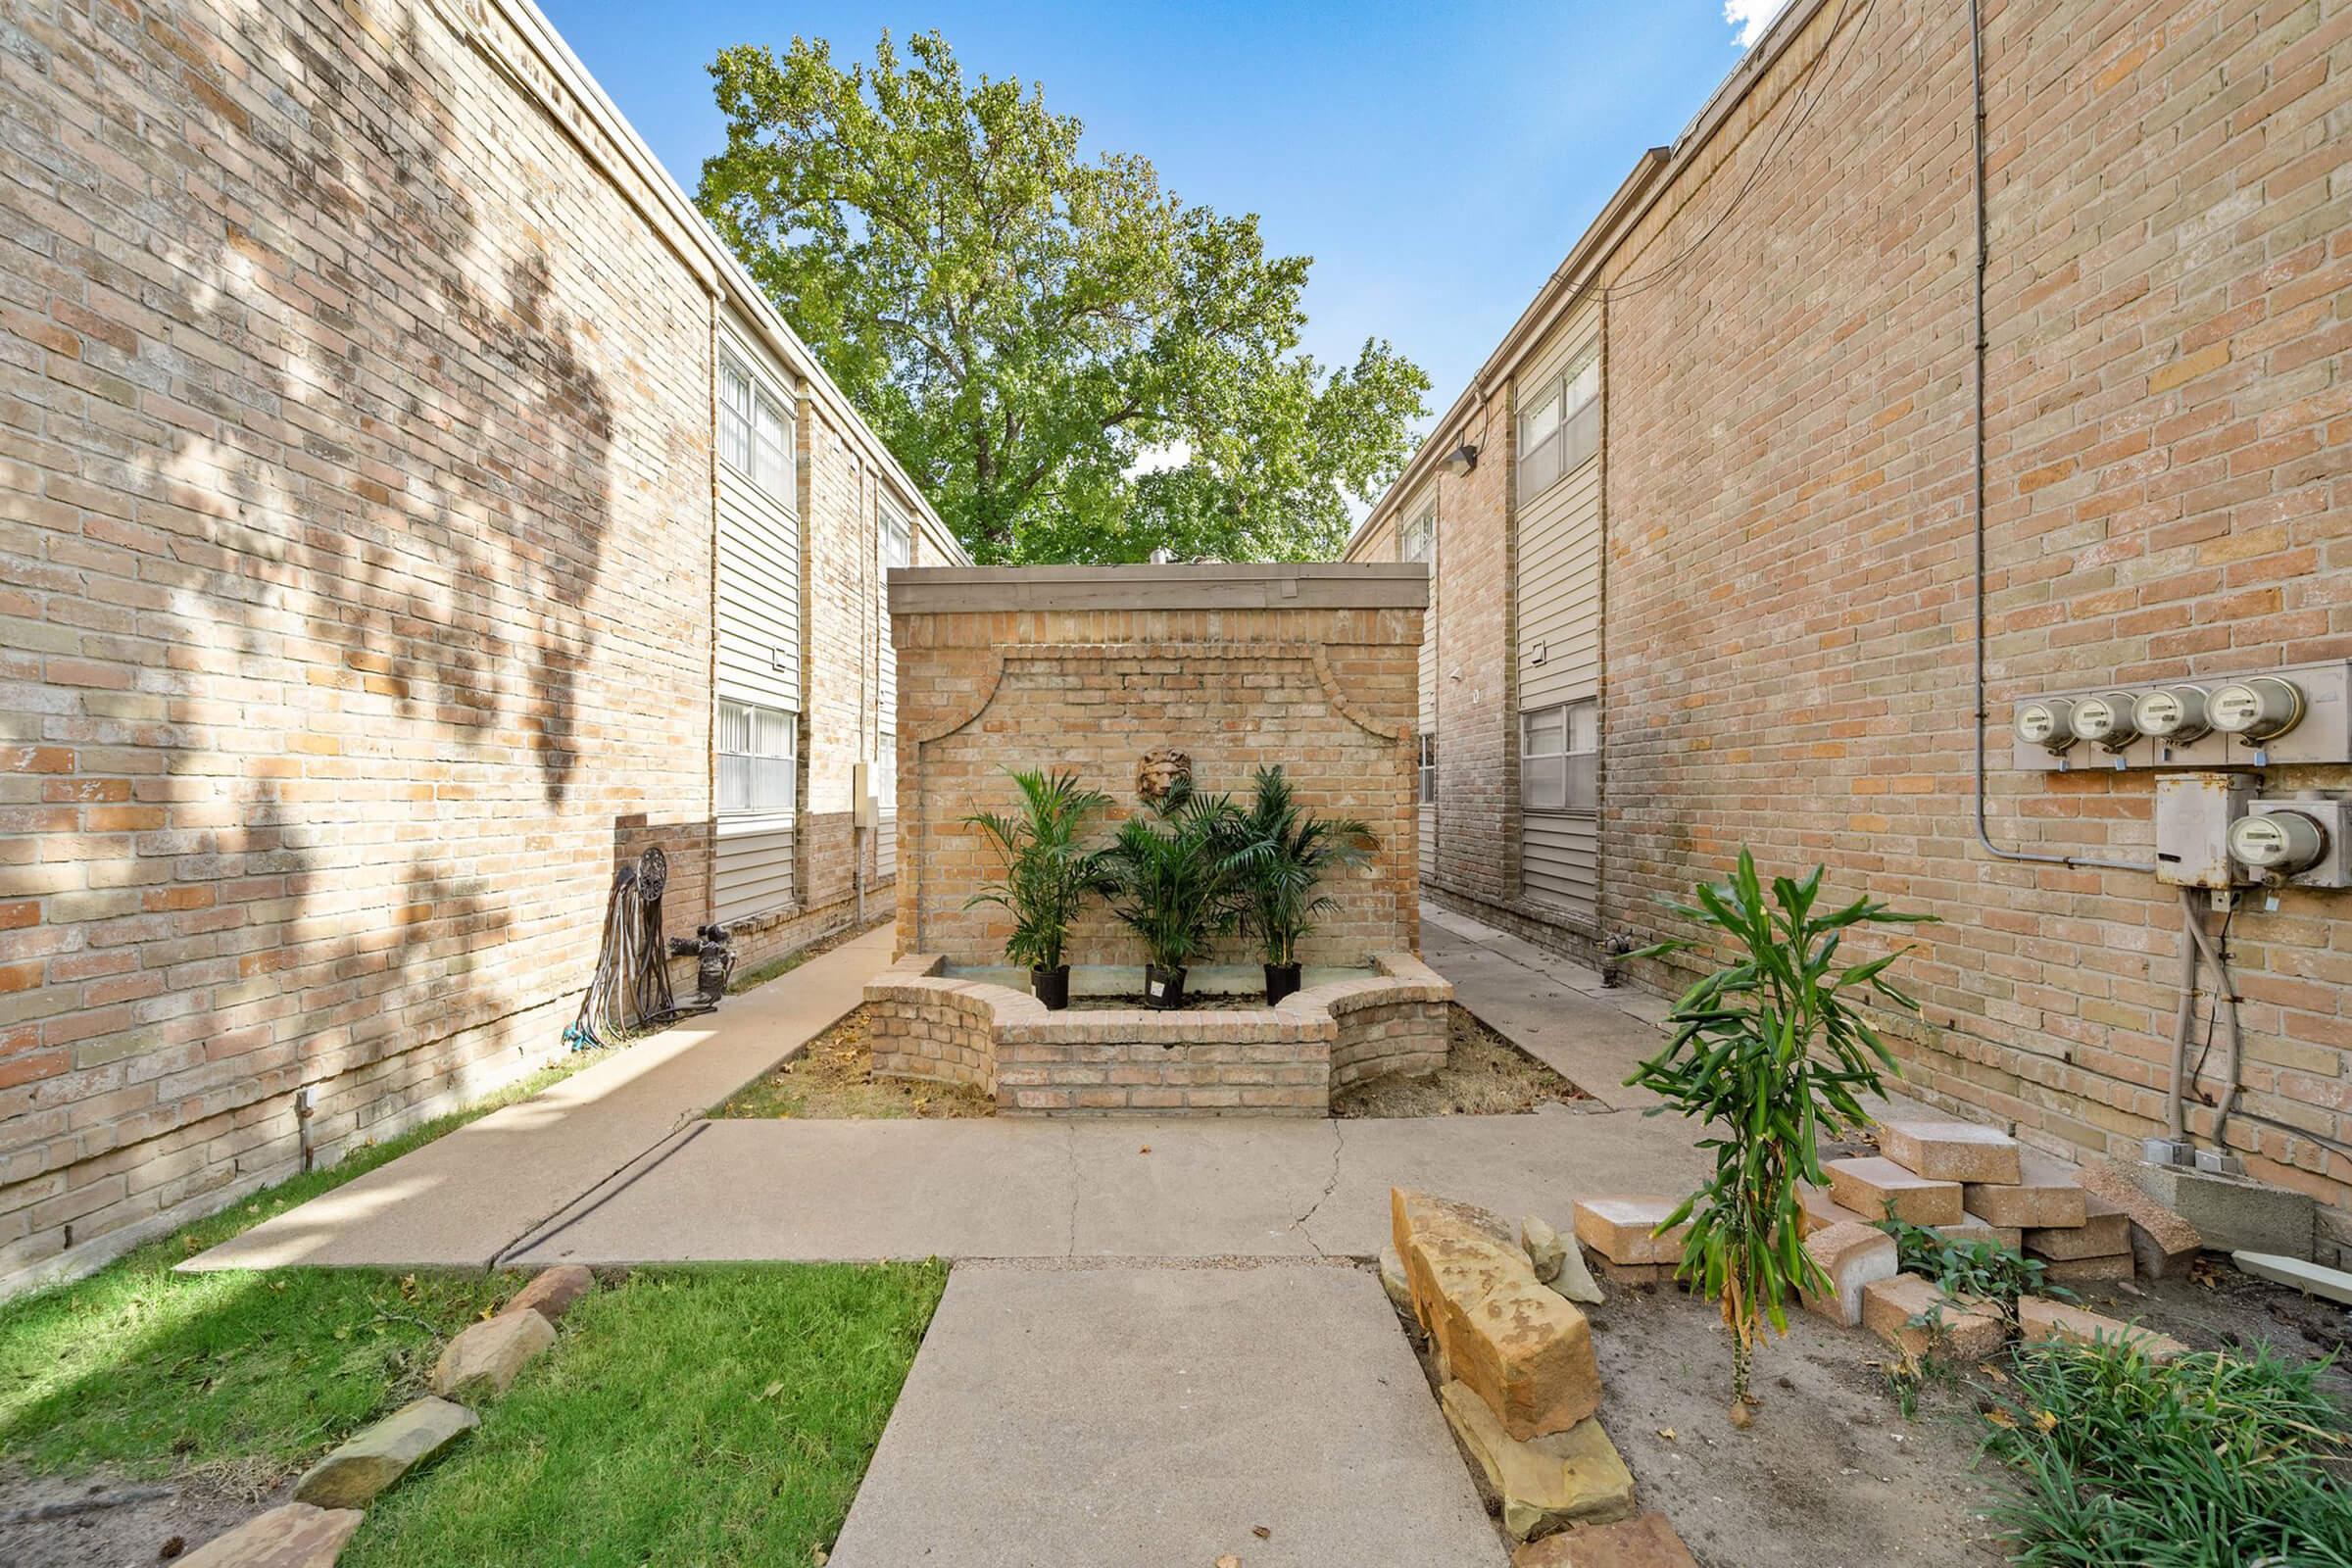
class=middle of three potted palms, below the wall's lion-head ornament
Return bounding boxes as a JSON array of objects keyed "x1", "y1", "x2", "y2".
[{"x1": 1103, "y1": 790, "x2": 1240, "y2": 1008}]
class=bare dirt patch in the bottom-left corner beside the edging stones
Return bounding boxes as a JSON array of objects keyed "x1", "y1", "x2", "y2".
[{"x1": 0, "y1": 1467, "x2": 294, "y2": 1568}]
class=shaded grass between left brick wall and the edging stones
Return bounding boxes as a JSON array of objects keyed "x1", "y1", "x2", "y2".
[{"x1": 0, "y1": 1055, "x2": 598, "y2": 1479}]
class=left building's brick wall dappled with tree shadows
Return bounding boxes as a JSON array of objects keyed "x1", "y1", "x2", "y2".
[{"x1": 0, "y1": 0, "x2": 945, "y2": 1291}]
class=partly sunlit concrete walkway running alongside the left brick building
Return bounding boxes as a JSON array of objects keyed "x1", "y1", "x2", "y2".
[{"x1": 181, "y1": 926, "x2": 892, "y2": 1269}]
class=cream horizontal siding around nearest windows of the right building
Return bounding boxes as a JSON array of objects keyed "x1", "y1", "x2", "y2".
[{"x1": 1512, "y1": 303, "x2": 1601, "y2": 926}]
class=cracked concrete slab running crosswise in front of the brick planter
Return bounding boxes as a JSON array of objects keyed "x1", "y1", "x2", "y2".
[{"x1": 513, "y1": 1107, "x2": 1705, "y2": 1267}]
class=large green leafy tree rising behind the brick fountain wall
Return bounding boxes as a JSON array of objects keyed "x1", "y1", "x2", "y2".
[{"x1": 699, "y1": 33, "x2": 1430, "y2": 562}]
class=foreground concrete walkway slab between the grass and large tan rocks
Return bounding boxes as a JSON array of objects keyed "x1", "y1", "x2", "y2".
[{"x1": 830, "y1": 1259, "x2": 1505, "y2": 1568}]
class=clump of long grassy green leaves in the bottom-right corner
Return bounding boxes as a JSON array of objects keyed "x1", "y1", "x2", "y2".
[{"x1": 1985, "y1": 1340, "x2": 2352, "y2": 1568}]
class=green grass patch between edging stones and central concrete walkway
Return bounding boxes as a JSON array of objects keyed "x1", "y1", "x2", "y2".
[{"x1": 341, "y1": 1262, "x2": 948, "y2": 1568}]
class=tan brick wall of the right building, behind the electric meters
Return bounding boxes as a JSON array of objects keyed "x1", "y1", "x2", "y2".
[{"x1": 1357, "y1": 0, "x2": 2352, "y2": 1239}]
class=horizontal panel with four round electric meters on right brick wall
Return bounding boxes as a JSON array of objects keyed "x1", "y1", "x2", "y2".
[{"x1": 2009, "y1": 659, "x2": 2352, "y2": 773}]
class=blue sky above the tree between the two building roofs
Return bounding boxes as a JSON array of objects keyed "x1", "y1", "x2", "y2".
[{"x1": 541, "y1": 0, "x2": 1781, "y2": 432}]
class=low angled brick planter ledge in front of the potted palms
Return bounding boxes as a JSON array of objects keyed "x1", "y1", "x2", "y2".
[{"x1": 865, "y1": 953, "x2": 1453, "y2": 1116}]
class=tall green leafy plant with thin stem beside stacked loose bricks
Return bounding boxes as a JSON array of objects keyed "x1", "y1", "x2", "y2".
[{"x1": 1625, "y1": 849, "x2": 1934, "y2": 1427}]
